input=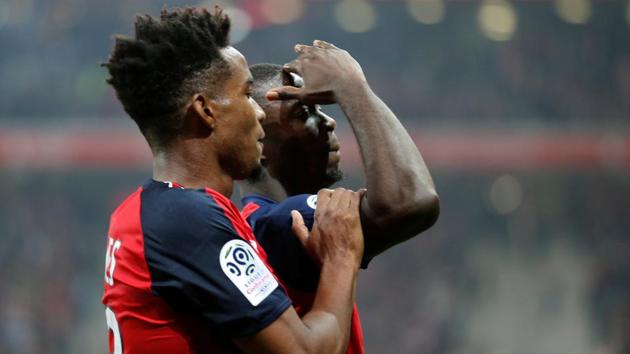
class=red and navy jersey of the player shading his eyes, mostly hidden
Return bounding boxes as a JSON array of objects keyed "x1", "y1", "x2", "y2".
[{"x1": 241, "y1": 194, "x2": 367, "y2": 354}]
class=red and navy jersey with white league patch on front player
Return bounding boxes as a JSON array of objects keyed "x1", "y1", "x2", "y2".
[{"x1": 102, "y1": 180, "x2": 291, "y2": 354}]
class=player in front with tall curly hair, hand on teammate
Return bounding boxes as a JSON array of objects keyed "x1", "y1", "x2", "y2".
[{"x1": 102, "y1": 9, "x2": 363, "y2": 354}]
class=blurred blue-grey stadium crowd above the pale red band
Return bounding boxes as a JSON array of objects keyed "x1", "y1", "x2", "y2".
[{"x1": 0, "y1": 0, "x2": 630, "y2": 129}]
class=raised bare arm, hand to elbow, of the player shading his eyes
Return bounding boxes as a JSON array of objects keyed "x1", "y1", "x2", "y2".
[{"x1": 268, "y1": 41, "x2": 439, "y2": 258}]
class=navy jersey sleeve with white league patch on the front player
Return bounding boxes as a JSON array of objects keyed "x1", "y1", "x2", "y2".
[{"x1": 141, "y1": 189, "x2": 291, "y2": 337}]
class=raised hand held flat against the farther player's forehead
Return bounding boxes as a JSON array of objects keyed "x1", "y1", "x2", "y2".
[{"x1": 267, "y1": 40, "x2": 367, "y2": 104}]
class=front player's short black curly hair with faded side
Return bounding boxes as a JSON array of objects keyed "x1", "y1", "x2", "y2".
[{"x1": 103, "y1": 7, "x2": 230, "y2": 149}]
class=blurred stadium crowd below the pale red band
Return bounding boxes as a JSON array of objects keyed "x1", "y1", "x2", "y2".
[{"x1": 0, "y1": 171, "x2": 630, "y2": 354}]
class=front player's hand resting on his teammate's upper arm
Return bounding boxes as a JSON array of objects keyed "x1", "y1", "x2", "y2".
[{"x1": 291, "y1": 188, "x2": 365, "y2": 267}]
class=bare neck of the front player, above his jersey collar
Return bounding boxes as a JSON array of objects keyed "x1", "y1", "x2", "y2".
[{"x1": 153, "y1": 144, "x2": 233, "y2": 198}]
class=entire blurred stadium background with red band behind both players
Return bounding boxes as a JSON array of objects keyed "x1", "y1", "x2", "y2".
[{"x1": 0, "y1": 0, "x2": 630, "y2": 354}]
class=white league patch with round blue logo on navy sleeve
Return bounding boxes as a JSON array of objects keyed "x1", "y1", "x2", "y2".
[{"x1": 220, "y1": 240, "x2": 278, "y2": 306}]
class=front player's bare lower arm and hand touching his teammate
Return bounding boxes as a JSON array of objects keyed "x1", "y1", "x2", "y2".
[{"x1": 236, "y1": 188, "x2": 363, "y2": 354}]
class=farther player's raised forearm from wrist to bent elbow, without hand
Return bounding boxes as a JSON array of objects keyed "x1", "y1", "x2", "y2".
[{"x1": 337, "y1": 83, "x2": 439, "y2": 255}]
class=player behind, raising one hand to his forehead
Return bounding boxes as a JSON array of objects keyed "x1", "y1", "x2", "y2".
[{"x1": 239, "y1": 41, "x2": 439, "y2": 354}]
